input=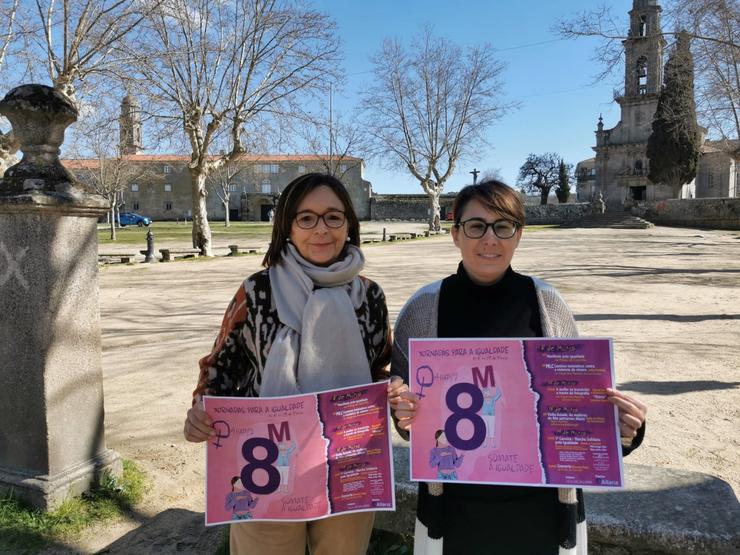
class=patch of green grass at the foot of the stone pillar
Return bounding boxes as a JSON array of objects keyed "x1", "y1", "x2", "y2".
[{"x1": 0, "y1": 460, "x2": 147, "y2": 553}]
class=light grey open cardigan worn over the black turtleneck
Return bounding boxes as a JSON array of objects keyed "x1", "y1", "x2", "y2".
[{"x1": 391, "y1": 278, "x2": 588, "y2": 555}]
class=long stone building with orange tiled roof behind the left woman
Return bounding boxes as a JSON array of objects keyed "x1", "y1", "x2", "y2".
[{"x1": 62, "y1": 99, "x2": 372, "y2": 221}]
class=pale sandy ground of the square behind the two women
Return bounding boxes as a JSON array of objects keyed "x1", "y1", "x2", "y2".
[{"x1": 65, "y1": 226, "x2": 740, "y2": 549}]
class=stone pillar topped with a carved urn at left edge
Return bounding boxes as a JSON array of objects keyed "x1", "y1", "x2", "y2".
[{"x1": 0, "y1": 85, "x2": 121, "y2": 509}]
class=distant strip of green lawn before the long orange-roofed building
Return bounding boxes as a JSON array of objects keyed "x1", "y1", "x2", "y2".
[{"x1": 98, "y1": 222, "x2": 272, "y2": 249}]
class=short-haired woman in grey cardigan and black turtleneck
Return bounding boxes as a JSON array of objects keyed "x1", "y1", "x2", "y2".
[{"x1": 391, "y1": 181, "x2": 646, "y2": 555}]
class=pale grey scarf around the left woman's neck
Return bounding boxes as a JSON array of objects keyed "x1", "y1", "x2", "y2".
[{"x1": 260, "y1": 243, "x2": 371, "y2": 397}]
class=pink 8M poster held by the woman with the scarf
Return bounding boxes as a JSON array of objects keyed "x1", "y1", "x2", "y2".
[{"x1": 204, "y1": 382, "x2": 395, "y2": 525}]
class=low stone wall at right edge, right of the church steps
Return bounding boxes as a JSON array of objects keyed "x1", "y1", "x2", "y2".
[{"x1": 632, "y1": 198, "x2": 740, "y2": 229}]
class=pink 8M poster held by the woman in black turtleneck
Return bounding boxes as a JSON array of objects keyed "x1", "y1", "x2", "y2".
[{"x1": 409, "y1": 338, "x2": 624, "y2": 488}]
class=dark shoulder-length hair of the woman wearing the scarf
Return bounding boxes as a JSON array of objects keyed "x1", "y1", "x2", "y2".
[{"x1": 262, "y1": 173, "x2": 360, "y2": 268}]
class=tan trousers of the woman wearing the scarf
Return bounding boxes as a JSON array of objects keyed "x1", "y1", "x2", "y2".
[{"x1": 229, "y1": 512, "x2": 375, "y2": 555}]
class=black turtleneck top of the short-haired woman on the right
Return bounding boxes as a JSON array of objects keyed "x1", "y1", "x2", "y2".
[{"x1": 434, "y1": 263, "x2": 560, "y2": 555}]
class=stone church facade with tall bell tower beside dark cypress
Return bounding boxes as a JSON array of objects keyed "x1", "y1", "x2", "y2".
[{"x1": 576, "y1": 0, "x2": 740, "y2": 206}]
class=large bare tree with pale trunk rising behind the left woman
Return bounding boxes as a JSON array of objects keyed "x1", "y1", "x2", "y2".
[{"x1": 131, "y1": 0, "x2": 339, "y2": 256}]
